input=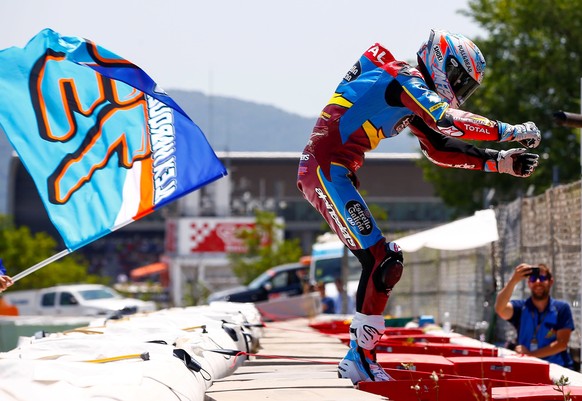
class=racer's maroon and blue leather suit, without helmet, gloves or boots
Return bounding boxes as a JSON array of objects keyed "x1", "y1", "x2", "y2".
[{"x1": 297, "y1": 43, "x2": 504, "y2": 315}]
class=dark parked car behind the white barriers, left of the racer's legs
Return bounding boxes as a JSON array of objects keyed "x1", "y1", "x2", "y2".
[{"x1": 208, "y1": 263, "x2": 309, "y2": 302}]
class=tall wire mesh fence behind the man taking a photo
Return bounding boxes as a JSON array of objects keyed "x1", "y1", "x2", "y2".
[{"x1": 388, "y1": 181, "x2": 582, "y2": 368}]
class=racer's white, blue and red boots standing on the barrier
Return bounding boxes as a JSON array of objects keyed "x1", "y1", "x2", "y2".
[{"x1": 338, "y1": 312, "x2": 393, "y2": 385}]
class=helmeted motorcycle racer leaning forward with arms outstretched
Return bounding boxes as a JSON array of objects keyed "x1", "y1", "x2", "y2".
[{"x1": 297, "y1": 30, "x2": 541, "y2": 384}]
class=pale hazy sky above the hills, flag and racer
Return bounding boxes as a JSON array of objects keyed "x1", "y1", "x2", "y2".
[{"x1": 0, "y1": 0, "x2": 485, "y2": 117}]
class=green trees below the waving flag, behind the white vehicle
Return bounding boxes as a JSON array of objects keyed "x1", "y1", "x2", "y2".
[{"x1": 0, "y1": 216, "x2": 104, "y2": 290}]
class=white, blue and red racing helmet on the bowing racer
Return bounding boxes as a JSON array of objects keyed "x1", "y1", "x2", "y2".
[{"x1": 417, "y1": 29, "x2": 485, "y2": 108}]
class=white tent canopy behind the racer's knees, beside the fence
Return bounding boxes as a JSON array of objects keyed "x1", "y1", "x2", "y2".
[{"x1": 395, "y1": 209, "x2": 499, "y2": 252}]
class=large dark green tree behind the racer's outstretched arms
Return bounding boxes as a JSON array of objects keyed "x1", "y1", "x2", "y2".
[{"x1": 420, "y1": 0, "x2": 582, "y2": 214}]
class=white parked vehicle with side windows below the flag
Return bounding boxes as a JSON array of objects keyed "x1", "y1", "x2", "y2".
[{"x1": 1, "y1": 284, "x2": 156, "y2": 316}]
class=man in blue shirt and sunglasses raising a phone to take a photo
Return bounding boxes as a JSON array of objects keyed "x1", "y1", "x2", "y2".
[{"x1": 495, "y1": 263, "x2": 574, "y2": 368}]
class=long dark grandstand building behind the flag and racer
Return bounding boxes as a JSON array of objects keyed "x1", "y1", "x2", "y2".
[{"x1": 7, "y1": 152, "x2": 450, "y2": 277}]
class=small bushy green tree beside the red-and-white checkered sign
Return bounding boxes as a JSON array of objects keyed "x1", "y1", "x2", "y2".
[{"x1": 228, "y1": 210, "x2": 302, "y2": 284}]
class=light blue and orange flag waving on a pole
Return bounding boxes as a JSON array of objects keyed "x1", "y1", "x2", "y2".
[{"x1": 0, "y1": 29, "x2": 226, "y2": 251}]
